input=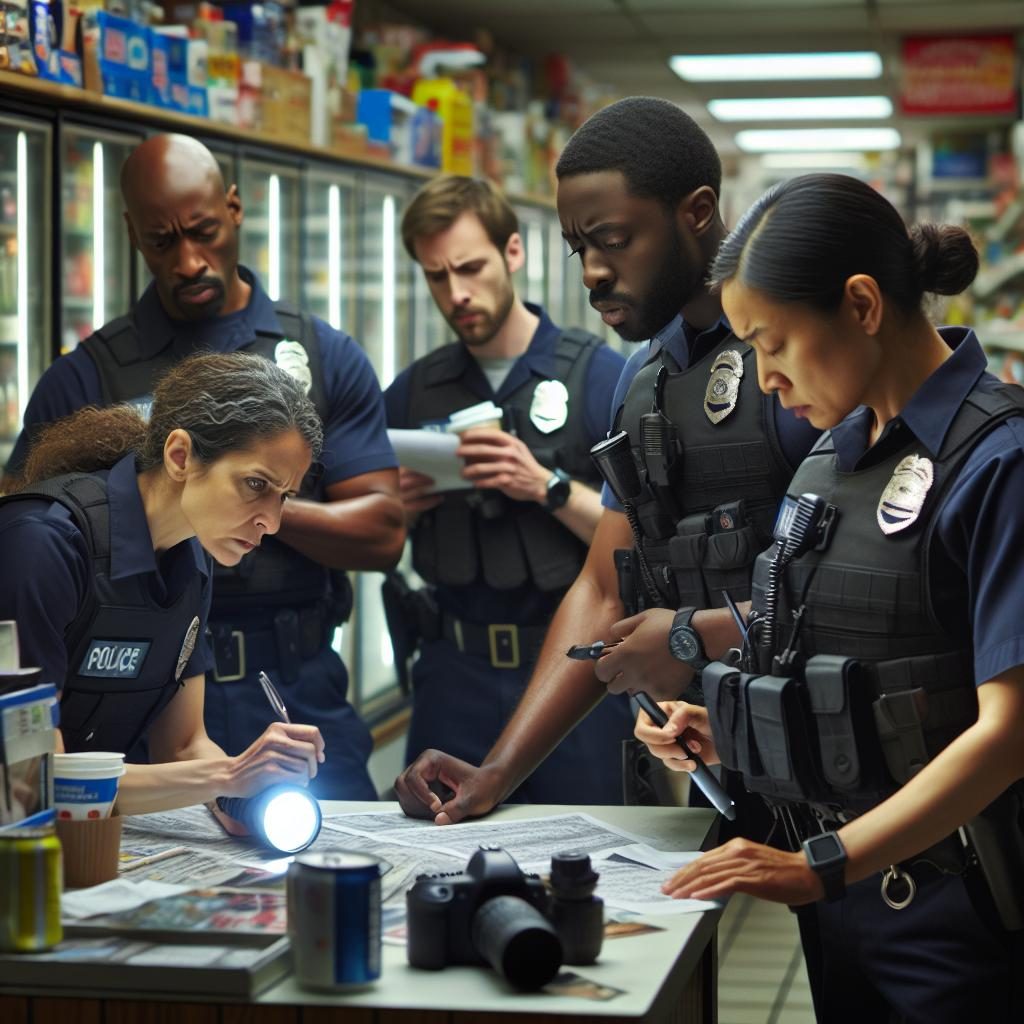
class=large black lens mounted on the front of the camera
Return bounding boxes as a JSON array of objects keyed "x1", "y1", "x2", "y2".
[{"x1": 472, "y1": 896, "x2": 562, "y2": 991}]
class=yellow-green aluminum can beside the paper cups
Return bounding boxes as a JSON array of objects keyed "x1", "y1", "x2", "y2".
[{"x1": 0, "y1": 828, "x2": 63, "y2": 952}]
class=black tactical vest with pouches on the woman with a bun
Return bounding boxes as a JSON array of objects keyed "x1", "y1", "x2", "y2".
[{"x1": 703, "y1": 383, "x2": 1024, "y2": 812}]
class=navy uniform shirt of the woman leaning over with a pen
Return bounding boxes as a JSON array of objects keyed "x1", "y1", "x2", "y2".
[{"x1": 0, "y1": 456, "x2": 212, "y2": 687}]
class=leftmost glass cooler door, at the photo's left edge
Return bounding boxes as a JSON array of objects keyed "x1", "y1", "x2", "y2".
[{"x1": 0, "y1": 118, "x2": 52, "y2": 469}]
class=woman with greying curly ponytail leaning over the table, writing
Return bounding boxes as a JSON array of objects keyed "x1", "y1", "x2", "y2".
[{"x1": 0, "y1": 353, "x2": 324, "y2": 814}]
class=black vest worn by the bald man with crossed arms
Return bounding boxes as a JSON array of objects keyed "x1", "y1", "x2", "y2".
[{"x1": 82, "y1": 302, "x2": 335, "y2": 621}]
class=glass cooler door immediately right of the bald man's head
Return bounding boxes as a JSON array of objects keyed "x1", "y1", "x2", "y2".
[{"x1": 239, "y1": 158, "x2": 301, "y2": 302}]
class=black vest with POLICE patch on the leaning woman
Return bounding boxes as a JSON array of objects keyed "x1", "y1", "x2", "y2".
[{"x1": 0, "y1": 473, "x2": 203, "y2": 753}]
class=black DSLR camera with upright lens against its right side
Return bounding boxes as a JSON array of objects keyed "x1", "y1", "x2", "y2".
[{"x1": 406, "y1": 846, "x2": 604, "y2": 989}]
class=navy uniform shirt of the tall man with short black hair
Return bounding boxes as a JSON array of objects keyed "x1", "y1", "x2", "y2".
[{"x1": 601, "y1": 316, "x2": 820, "y2": 512}]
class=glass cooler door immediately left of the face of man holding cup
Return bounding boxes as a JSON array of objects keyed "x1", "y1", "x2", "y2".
[{"x1": 345, "y1": 176, "x2": 415, "y2": 713}]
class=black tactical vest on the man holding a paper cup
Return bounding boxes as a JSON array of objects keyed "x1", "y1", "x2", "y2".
[{"x1": 409, "y1": 329, "x2": 602, "y2": 591}]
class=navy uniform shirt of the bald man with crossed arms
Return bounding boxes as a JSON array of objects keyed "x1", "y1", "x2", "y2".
[{"x1": 7, "y1": 266, "x2": 398, "y2": 485}]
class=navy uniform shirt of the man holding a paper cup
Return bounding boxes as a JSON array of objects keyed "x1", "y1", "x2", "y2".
[{"x1": 384, "y1": 302, "x2": 626, "y2": 625}]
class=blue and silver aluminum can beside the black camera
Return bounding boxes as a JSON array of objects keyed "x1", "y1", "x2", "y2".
[{"x1": 288, "y1": 850, "x2": 381, "y2": 991}]
